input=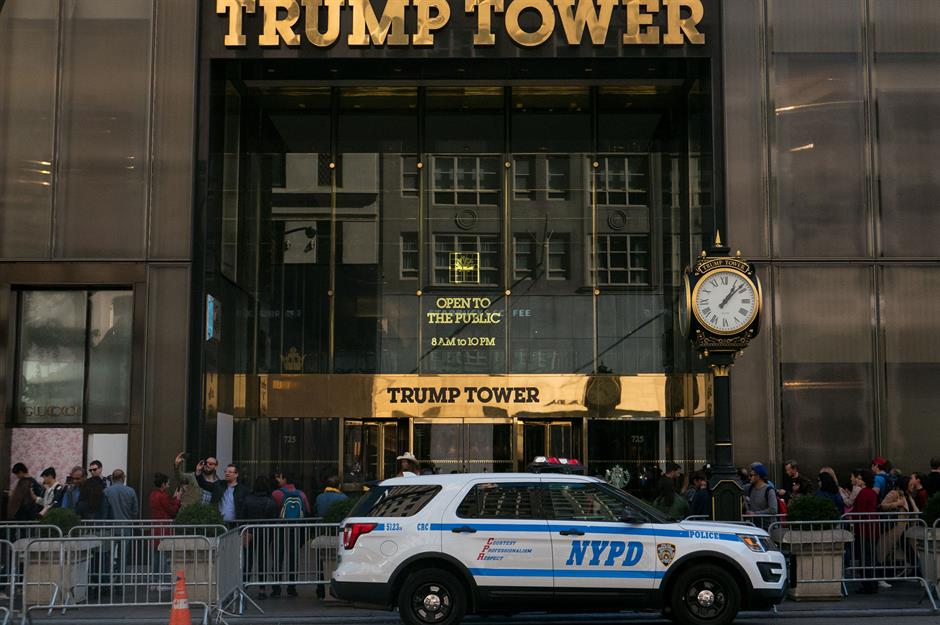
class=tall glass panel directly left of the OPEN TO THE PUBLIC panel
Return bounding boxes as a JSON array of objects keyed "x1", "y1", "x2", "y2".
[{"x1": 334, "y1": 87, "x2": 421, "y2": 373}]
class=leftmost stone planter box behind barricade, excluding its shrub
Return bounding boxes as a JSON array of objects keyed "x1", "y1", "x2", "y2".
[{"x1": 13, "y1": 538, "x2": 101, "y2": 606}]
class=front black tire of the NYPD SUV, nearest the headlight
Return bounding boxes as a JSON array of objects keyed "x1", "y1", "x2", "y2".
[{"x1": 669, "y1": 564, "x2": 741, "y2": 625}]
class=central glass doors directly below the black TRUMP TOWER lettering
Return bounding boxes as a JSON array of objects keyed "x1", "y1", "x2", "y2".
[{"x1": 414, "y1": 419, "x2": 513, "y2": 473}]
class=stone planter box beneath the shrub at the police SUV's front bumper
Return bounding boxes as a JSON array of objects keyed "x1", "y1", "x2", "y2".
[{"x1": 773, "y1": 528, "x2": 854, "y2": 601}]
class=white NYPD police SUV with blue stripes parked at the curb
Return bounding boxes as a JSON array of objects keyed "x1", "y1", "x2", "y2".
[{"x1": 331, "y1": 473, "x2": 787, "y2": 625}]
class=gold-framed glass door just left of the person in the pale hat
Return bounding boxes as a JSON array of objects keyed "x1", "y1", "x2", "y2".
[{"x1": 343, "y1": 420, "x2": 403, "y2": 488}]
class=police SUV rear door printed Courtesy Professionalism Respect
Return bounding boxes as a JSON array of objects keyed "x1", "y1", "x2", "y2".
[{"x1": 441, "y1": 476, "x2": 553, "y2": 607}]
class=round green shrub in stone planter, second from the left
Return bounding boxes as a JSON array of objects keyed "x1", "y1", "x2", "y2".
[{"x1": 154, "y1": 503, "x2": 225, "y2": 603}]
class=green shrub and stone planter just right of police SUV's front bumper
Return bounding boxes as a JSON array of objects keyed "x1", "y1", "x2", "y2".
[{"x1": 773, "y1": 495, "x2": 854, "y2": 601}]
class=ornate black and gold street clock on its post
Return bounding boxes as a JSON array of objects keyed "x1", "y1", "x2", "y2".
[{"x1": 679, "y1": 233, "x2": 762, "y2": 521}]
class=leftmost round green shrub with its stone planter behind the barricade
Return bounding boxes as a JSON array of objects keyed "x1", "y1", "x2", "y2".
[{"x1": 13, "y1": 508, "x2": 101, "y2": 606}]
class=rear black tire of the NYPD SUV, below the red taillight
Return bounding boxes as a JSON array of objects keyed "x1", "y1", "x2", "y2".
[{"x1": 398, "y1": 569, "x2": 467, "y2": 625}]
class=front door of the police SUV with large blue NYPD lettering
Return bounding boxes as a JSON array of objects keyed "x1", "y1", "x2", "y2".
[{"x1": 543, "y1": 478, "x2": 661, "y2": 605}]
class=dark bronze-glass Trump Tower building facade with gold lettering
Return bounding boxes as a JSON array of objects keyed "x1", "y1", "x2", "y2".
[{"x1": 0, "y1": 0, "x2": 940, "y2": 504}]
